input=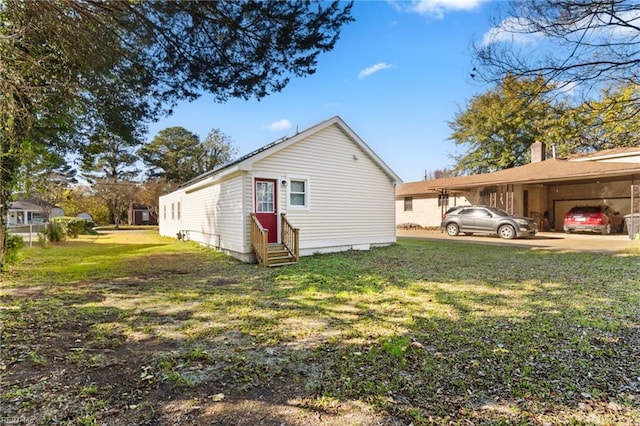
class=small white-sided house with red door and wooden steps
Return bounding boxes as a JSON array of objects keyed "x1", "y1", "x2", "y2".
[{"x1": 159, "y1": 117, "x2": 401, "y2": 264}]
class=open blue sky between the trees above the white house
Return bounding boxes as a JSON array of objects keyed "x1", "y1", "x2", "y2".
[{"x1": 148, "y1": 0, "x2": 496, "y2": 182}]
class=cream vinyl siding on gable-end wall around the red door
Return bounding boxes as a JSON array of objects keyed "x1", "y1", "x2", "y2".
[{"x1": 253, "y1": 126, "x2": 395, "y2": 251}]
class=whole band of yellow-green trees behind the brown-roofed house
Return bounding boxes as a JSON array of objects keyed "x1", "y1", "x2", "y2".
[{"x1": 449, "y1": 75, "x2": 640, "y2": 173}]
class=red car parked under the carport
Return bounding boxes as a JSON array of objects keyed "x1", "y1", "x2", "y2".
[{"x1": 564, "y1": 206, "x2": 624, "y2": 235}]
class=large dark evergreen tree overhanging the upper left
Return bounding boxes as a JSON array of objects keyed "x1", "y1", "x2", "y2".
[{"x1": 0, "y1": 0, "x2": 352, "y2": 266}]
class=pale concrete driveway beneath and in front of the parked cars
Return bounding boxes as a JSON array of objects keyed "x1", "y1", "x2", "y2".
[{"x1": 396, "y1": 229, "x2": 640, "y2": 253}]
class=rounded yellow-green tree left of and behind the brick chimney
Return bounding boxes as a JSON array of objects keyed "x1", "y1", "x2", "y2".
[{"x1": 449, "y1": 75, "x2": 555, "y2": 174}]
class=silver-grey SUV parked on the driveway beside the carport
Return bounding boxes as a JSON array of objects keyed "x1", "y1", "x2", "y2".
[{"x1": 440, "y1": 206, "x2": 536, "y2": 240}]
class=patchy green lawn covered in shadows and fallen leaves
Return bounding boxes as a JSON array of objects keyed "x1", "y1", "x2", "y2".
[{"x1": 0, "y1": 231, "x2": 640, "y2": 425}]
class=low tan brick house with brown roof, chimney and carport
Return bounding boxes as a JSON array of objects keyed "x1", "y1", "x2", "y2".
[{"x1": 396, "y1": 142, "x2": 640, "y2": 230}]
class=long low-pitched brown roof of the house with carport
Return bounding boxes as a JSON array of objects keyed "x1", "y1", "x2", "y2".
[{"x1": 396, "y1": 159, "x2": 640, "y2": 196}]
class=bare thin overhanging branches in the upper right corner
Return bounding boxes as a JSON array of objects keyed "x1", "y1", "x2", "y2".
[{"x1": 473, "y1": 0, "x2": 640, "y2": 104}]
